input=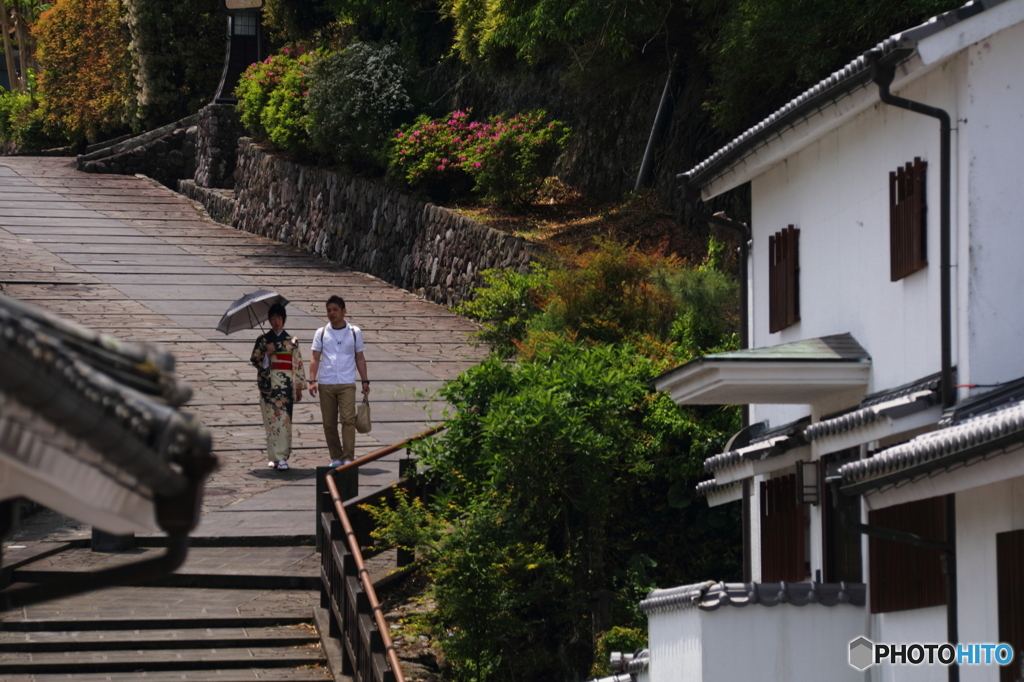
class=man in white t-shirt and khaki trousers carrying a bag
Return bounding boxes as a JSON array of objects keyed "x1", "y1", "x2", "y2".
[{"x1": 309, "y1": 296, "x2": 370, "y2": 467}]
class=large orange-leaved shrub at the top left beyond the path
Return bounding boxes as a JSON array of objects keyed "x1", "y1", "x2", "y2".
[{"x1": 33, "y1": 0, "x2": 137, "y2": 142}]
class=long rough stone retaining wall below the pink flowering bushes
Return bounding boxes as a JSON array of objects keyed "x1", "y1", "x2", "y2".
[{"x1": 232, "y1": 138, "x2": 539, "y2": 305}]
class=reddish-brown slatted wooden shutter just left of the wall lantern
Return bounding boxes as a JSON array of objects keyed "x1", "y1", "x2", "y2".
[{"x1": 761, "y1": 474, "x2": 807, "y2": 583}]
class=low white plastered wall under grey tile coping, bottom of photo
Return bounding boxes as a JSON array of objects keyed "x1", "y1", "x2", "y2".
[{"x1": 648, "y1": 604, "x2": 867, "y2": 682}]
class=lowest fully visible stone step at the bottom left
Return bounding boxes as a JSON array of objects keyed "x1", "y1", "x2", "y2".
[{"x1": 0, "y1": 644, "x2": 323, "y2": 676}]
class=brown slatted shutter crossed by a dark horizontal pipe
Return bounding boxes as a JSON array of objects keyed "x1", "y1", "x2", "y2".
[{"x1": 867, "y1": 497, "x2": 946, "y2": 613}]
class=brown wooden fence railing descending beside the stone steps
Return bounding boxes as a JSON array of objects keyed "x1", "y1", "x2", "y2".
[{"x1": 316, "y1": 425, "x2": 444, "y2": 682}]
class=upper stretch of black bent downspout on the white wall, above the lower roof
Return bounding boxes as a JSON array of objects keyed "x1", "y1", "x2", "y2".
[{"x1": 867, "y1": 50, "x2": 956, "y2": 408}]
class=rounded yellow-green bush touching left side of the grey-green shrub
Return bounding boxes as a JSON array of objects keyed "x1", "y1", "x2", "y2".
[{"x1": 234, "y1": 47, "x2": 313, "y2": 152}]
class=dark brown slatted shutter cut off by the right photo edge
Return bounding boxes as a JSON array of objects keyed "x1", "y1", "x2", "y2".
[{"x1": 995, "y1": 530, "x2": 1024, "y2": 682}]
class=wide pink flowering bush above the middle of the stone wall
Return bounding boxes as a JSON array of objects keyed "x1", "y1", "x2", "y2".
[{"x1": 389, "y1": 110, "x2": 569, "y2": 205}]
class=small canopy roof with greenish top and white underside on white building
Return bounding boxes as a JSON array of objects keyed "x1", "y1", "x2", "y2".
[{"x1": 651, "y1": 334, "x2": 871, "y2": 404}]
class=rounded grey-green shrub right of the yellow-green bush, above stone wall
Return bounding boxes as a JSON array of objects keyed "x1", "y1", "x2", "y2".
[{"x1": 306, "y1": 43, "x2": 413, "y2": 169}]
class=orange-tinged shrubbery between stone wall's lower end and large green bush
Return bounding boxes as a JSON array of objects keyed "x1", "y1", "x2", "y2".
[{"x1": 456, "y1": 240, "x2": 738, "y2": 357}]
